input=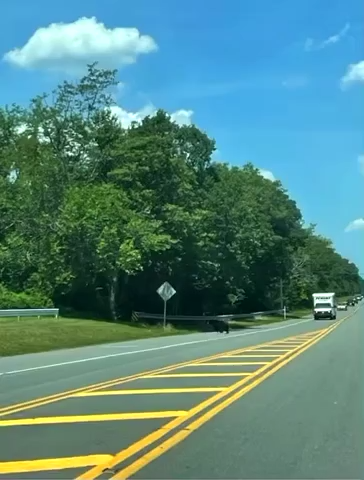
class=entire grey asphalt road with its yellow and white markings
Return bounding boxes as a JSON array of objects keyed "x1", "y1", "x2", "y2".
[{"x1": 0, "y1": 309, "x2": 364, "y2": 479}]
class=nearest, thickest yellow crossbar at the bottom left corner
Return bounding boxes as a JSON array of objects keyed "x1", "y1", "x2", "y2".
[{"x1": 0, "y1": 455, "x2": 112, "y2": 474}]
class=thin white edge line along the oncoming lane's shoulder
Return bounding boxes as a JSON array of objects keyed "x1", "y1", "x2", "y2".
[{"x1": 0, "y1": 318, "x2": 312, "y2": 376}]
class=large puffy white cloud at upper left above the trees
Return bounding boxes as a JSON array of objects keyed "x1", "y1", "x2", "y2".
[{"x1": 4, "y1": 17, "x2": 158, "y2": 73}]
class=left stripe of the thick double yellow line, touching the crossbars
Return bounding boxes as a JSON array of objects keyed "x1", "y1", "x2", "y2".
[{"x1": 76, "y1": 335, "x2": 328, "y2": 480}]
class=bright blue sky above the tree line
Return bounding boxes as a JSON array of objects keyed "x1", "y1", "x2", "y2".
[{"x1": 0, "y1": 0, "x2": 364, "y2": 275}]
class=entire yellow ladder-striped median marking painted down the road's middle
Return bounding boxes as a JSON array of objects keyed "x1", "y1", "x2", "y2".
[{"x1": 0, "y1": 312, "x2": 355, "y2": 480}]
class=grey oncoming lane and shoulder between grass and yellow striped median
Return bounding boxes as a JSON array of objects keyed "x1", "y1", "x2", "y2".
[{"x1": 0, "y1": 319, "x2": 338, "y2": 408}]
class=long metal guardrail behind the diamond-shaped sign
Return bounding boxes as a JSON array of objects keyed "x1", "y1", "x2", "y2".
[{"x1": 132, "y1": 308, "x2": 286, "y2": 322}]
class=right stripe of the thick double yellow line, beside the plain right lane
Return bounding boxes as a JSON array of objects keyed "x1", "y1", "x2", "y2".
[{"x1": 111, "y1": 323, "x2": 339, "y2": 480}]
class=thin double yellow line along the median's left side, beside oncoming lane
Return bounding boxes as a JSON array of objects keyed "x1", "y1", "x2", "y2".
[{"x1": 0, "y1": 337, "x2": 302, "y2": 417}]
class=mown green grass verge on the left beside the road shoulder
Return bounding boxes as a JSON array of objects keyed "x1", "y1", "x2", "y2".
[{"x1": 0, "y1": 318, "x2": 195, "y2": 357}]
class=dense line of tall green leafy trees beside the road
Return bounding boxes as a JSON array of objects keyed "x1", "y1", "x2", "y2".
[{"x1": 0, "y1": 65, "x2": 361, "y2": 319}]
